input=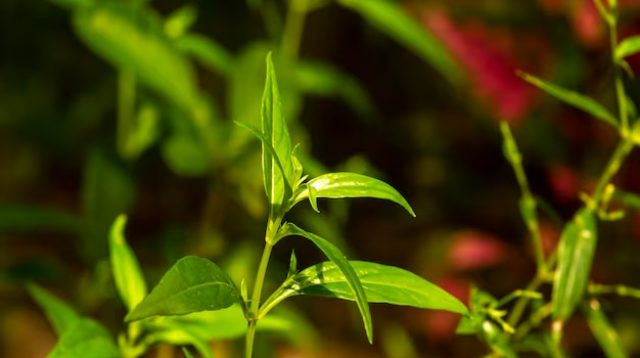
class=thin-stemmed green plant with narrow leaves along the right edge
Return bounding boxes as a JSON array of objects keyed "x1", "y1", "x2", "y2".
[{"x1": 458, "y1": 0, "x2": 640, "y2": 357}]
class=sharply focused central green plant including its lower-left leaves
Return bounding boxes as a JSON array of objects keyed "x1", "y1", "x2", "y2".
[{"x1": 30, "y1": 55, "x2": 467, "y2": 357}]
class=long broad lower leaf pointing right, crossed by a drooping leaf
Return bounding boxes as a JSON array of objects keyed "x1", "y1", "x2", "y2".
[{"x1": 274, "y1": 261, "x2": 468, "y2": 314}]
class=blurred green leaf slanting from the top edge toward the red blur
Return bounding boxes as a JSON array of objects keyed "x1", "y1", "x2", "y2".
[{"x1": 338, "y1": 0, "x2": 462, "y2": 83}]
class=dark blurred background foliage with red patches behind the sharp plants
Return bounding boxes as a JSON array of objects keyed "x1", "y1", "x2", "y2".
[{"x1": 0, "y1": 0, "x2": 640, "y2": 358}]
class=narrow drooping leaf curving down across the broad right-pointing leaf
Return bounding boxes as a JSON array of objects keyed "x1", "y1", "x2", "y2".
[{"x1": 278, "y1": 223, "x2": 373, "y2": 343}]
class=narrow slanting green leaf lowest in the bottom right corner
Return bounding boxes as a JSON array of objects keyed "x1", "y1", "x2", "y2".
[{"x1": 583, "y1": 299, "x2": 629, "y2": 358}]
